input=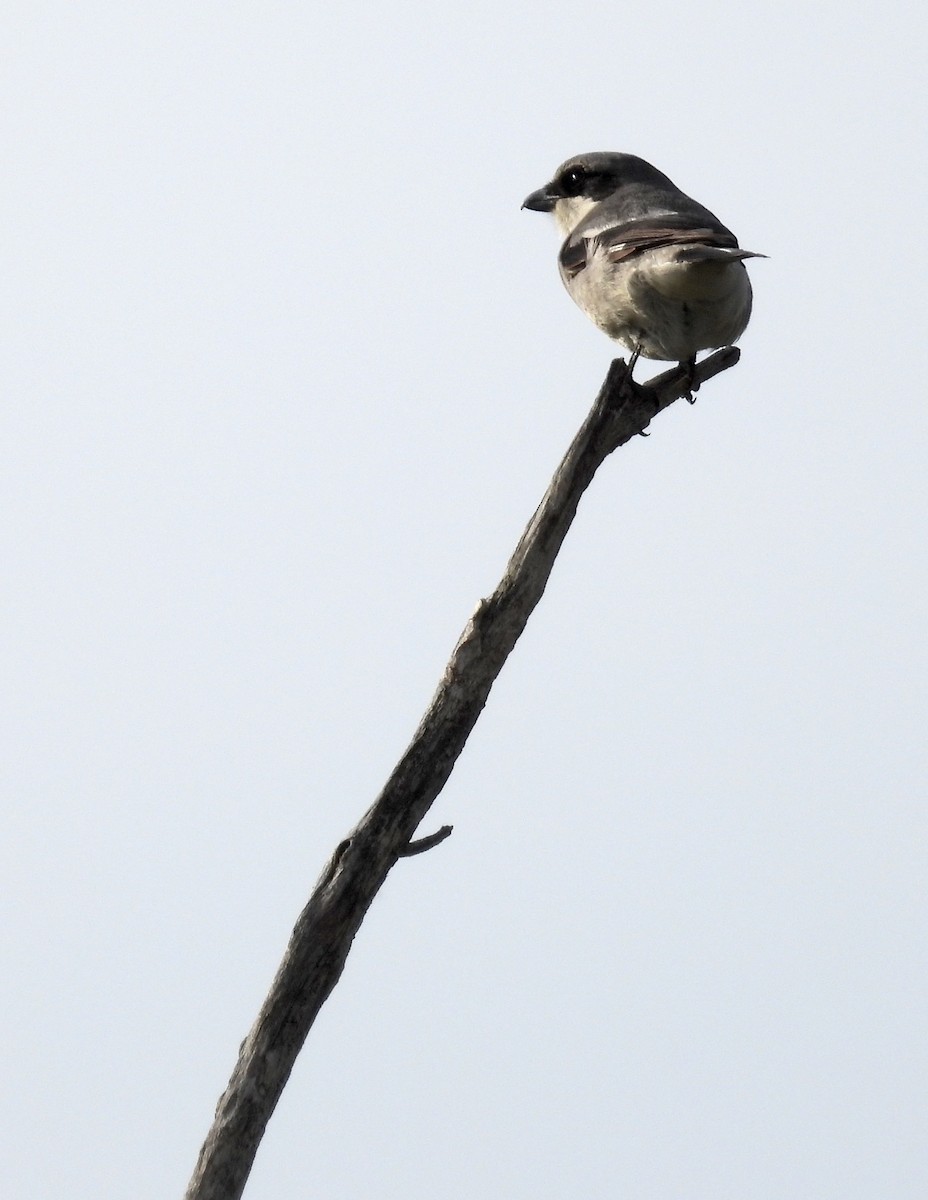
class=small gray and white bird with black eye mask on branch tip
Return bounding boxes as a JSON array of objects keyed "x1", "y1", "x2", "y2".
[{"x1": 522, "y1": 151, "x2": 766, "y2": 371}]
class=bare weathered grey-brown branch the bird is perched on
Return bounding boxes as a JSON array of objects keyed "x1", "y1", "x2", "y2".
[{"x1": 186, "y1": 348, "x2": 740, "y2": 1200}]
